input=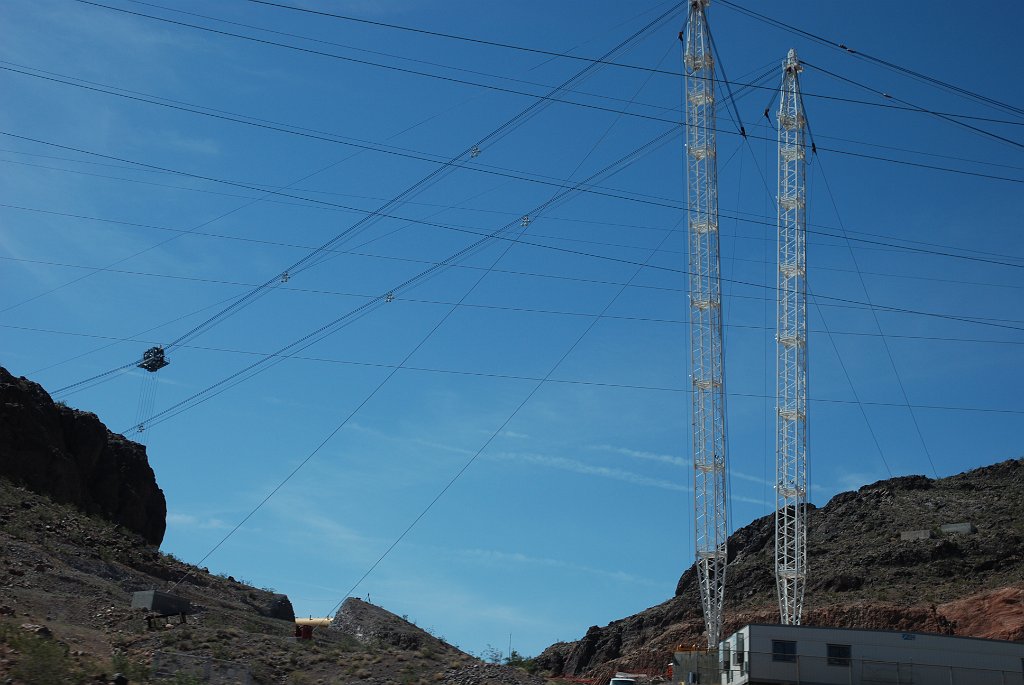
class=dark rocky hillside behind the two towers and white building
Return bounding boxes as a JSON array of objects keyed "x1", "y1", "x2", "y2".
[{"x1": 538, "y1": 460, "x2": 1024, "y2": 678}]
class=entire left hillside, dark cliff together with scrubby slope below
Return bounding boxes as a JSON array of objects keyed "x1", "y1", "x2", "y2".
[{"x1": 0, "y1": 369, "x2": 544, "y2": 685}]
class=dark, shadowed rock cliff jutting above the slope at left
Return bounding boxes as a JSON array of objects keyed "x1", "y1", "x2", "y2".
[{"x1": 0, "y1": 368, "x2": 167, "y2": 546}]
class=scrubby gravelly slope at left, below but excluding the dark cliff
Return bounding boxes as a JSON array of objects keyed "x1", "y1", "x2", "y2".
[{"x1": 0, "y1": 478, "x2": 544, "y2": 685}]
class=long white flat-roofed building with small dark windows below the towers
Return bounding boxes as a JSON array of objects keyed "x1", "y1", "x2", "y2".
[{"x1": 674, "y1": 625, "x2": 1024, "y2": 685}]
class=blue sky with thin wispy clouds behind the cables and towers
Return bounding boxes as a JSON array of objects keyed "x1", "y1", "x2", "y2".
[{"x1": 0, "y1": 0, "x2": 1024, "y2": 654}]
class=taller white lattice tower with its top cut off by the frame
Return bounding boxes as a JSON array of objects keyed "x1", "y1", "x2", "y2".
[{"x1": 683, "y1": 0, "x2": 728, "y2": 647}]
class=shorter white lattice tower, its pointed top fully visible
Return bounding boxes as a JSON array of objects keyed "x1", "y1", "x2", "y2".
[{"x1": 775, "y1": 50, "x2": 807, "y2": 626}]
